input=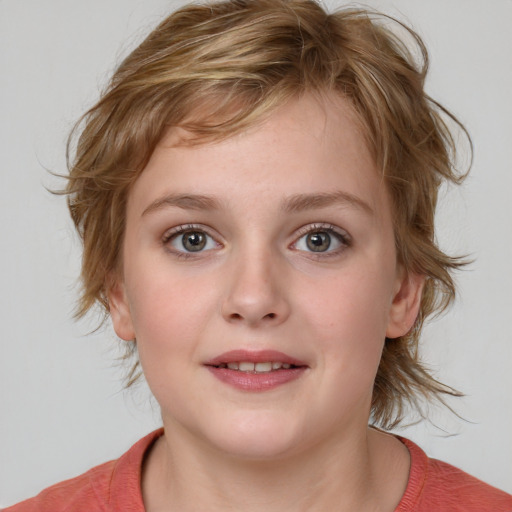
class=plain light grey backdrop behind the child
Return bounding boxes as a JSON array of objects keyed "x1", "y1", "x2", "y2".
[{"x1": 0, "y1": 0, "x2": 512, "y2": 506}]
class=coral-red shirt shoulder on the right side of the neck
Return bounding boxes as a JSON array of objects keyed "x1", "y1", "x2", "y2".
[{"x1": 396, "y1": 438, "x2": 512, "y2": 512}]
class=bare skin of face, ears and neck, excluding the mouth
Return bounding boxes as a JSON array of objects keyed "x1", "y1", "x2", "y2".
[{"x1": 110, "y1": 95, "x2": 423, "y2": 512}]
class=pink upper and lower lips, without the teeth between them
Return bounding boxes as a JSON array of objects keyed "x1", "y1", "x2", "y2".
[{"x1": 205, "y1": 350, "x2": 308, "y2": 392}]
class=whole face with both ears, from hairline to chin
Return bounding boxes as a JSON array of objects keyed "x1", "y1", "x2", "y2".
[{"x1": 110, "y1": 96, "x2": 421, "y2": 458}]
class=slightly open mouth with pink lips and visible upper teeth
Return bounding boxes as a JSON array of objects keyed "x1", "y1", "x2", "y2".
[{"x1": 205, "y1": 350, "x2": 309, "y2": 391}]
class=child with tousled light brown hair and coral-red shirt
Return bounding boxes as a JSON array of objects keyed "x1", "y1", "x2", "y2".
[{"x1": 4, "y1": 0, "x2": 512, "y2": 512}]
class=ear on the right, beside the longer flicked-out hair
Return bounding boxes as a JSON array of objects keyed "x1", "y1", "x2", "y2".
[{"x1": 386, "y1": 269, "x2": 425, "y2": 338}]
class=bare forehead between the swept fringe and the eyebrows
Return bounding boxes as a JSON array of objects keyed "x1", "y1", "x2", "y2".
[{"x1": 129, "y1": 95, "x2": 383, "y2": 222}]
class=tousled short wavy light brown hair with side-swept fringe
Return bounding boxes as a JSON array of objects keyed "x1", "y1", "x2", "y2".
[{"x1": 65, "y1": 0, "x2": 471, "y2": 428}]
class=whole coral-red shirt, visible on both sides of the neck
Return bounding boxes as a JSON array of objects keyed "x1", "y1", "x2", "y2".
[{"x1": 4, "y1": 429, "x2": 512, "y2": 512}]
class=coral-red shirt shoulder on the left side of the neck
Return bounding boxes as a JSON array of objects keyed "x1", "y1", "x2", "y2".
[{"x1": 3, "y1": 430, "x2": 162, "y2": 512}]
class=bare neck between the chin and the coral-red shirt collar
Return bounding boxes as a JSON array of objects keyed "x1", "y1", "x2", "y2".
[{"x1": 139, "y1": 429, "x2": 409, "y2": 512}]
